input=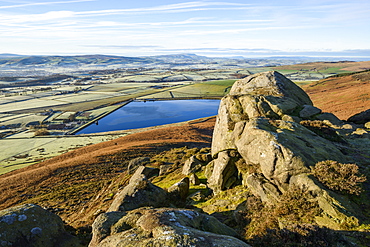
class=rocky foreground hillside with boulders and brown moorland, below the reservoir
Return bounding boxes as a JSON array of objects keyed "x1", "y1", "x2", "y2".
[{"x1": 0, "y1": 72, "x2": 370, "y2": 246}]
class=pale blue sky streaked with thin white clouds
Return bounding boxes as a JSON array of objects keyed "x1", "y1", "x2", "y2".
[{"x1": 0, "y1": 0, "x2": 370, "y2": 57}]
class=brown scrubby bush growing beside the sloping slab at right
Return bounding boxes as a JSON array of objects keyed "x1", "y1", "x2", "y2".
[{"x1": 311, "y1": 160, "x2": 366, "y2": 195}]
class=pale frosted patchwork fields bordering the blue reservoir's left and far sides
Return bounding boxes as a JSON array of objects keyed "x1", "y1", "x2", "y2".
[{"x1": 0, "y1": 80, "x2": 235, "y2": 174}]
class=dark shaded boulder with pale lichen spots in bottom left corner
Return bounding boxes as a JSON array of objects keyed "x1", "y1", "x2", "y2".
[{"x1": 0, "y1": 204, "x2": 82, "y2": 247}]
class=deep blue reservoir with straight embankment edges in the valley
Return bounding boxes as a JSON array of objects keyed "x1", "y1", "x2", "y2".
[{"x1": 76, "y1": 99, "x2": 220, "y2": 134}]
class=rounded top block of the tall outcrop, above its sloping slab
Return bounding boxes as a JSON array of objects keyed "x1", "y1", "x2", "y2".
[{"x1": 212, "y1": 71, "x2": 312, "y2": 156}]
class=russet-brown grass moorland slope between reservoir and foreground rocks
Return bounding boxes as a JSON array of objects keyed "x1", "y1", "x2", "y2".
[{"x1": 0, "y1": 118, "x2": 215, "y2": 226}]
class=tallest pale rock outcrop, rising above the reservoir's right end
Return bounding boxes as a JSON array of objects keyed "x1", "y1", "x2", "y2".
[{"x1": 208, "y1": 71, "x2": 368, "y2": 227}]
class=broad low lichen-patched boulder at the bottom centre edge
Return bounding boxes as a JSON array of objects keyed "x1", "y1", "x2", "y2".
[{"x1": 89, "y1": 208, "x2": 249, "y2": 247}]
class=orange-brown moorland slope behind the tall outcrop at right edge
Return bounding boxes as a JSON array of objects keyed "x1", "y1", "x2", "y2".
[{"x1": 303, "y1": 69, "x2": 370, "y2": 120}]
